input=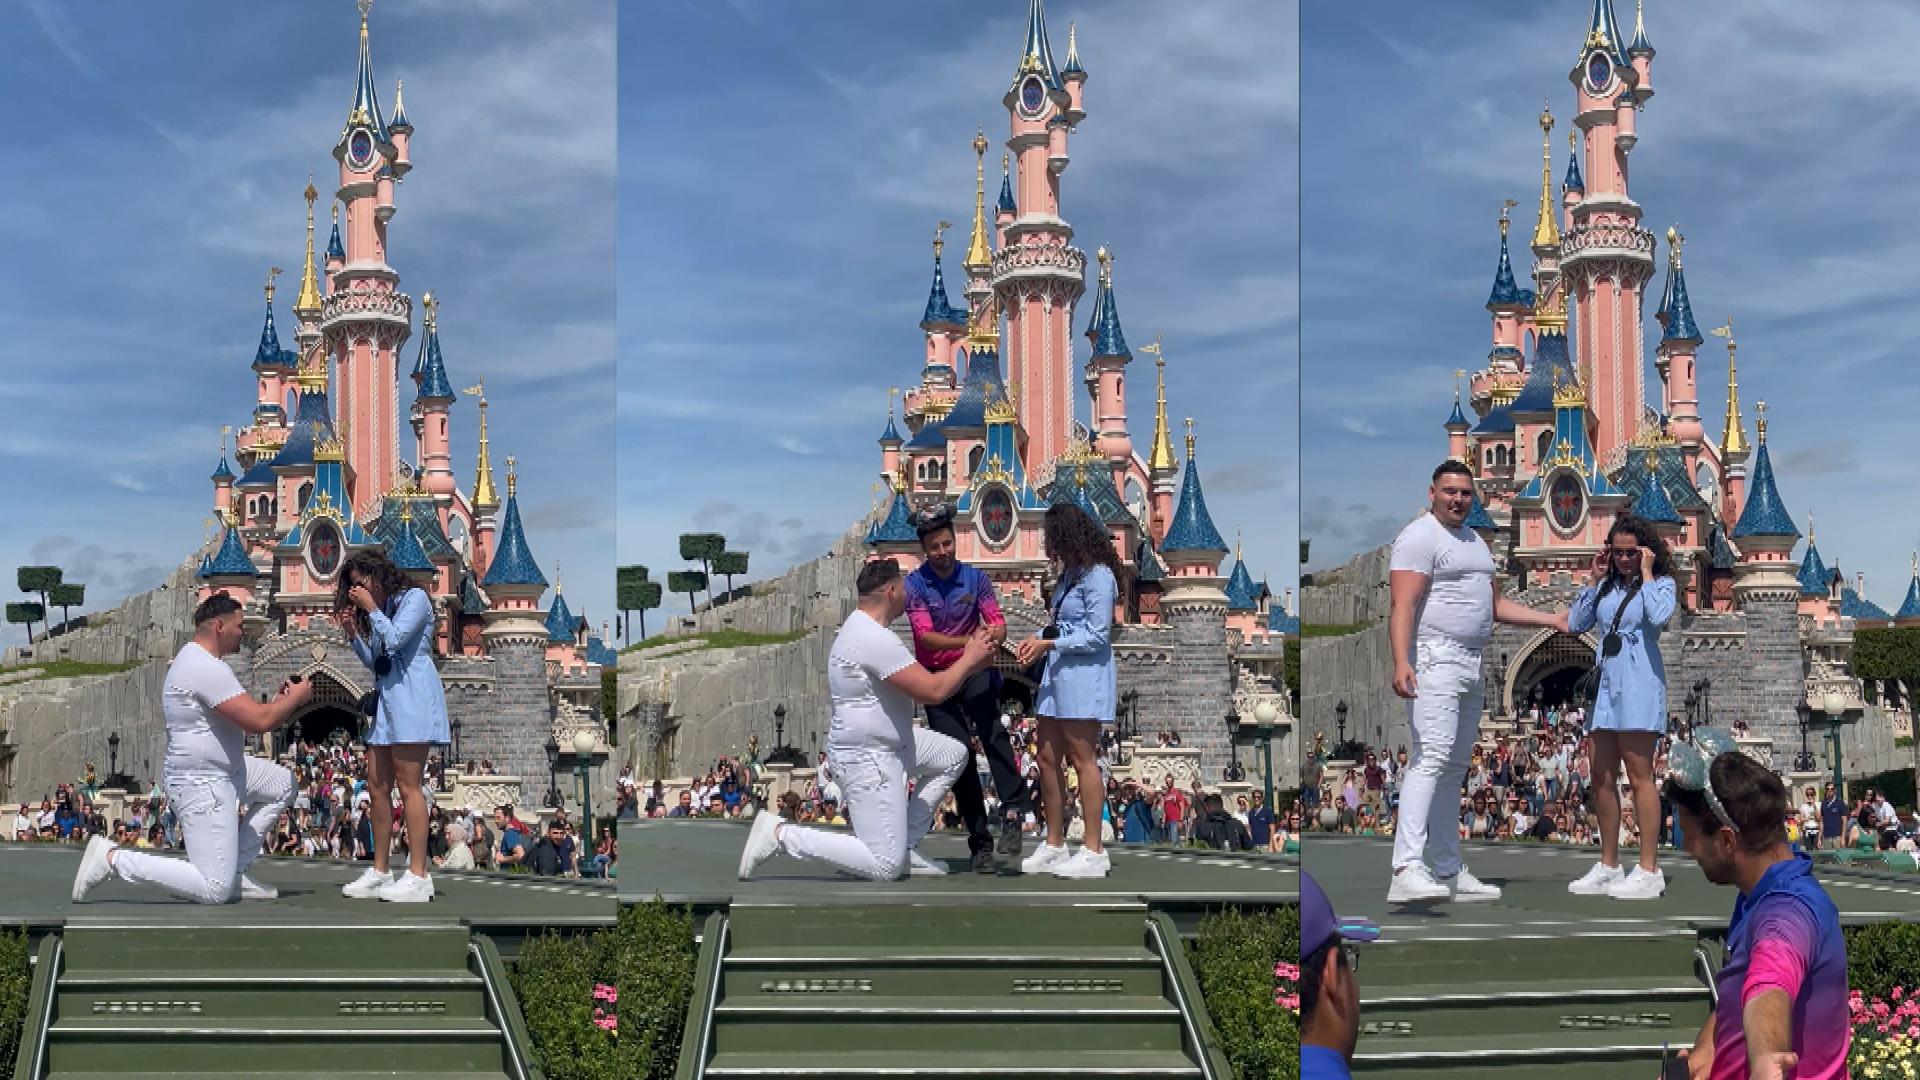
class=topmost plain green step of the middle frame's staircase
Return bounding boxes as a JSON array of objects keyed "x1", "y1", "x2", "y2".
[{"x1": 728, "y1": 903, "x2": 1146, "y2": 951}]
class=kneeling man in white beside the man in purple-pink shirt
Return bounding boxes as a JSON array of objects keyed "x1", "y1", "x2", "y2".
[{"x1": 739, "y1": 559, "x2": 995, "y2": 882}]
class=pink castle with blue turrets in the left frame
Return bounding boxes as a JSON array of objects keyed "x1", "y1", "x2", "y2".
[{"x1": 187, "y1": 0, "x2": 614, "y2": 786}]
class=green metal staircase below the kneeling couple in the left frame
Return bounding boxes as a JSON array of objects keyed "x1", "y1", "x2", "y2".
[{"x1": 15, "y1": 919, "x2": 540, "y2": 1080}]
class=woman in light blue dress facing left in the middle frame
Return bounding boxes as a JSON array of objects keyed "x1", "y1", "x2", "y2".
[{"x1": 1016, "y1": 503, "x2": 1119, "y2": 878}]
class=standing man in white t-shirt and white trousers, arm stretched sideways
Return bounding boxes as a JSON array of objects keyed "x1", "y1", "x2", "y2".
[{"x1": 1386, "y1": 461, "x2": 1567, "y2": 903}]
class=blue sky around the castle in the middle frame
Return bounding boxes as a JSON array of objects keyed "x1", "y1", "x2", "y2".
[{"x1": 618, "y1": 0, "x2": 1298, "y2": 630}]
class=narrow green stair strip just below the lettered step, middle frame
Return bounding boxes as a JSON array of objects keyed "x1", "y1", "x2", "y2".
[{"x1": 714, "y1": 994, "x2": 1181, "y2": 1022}]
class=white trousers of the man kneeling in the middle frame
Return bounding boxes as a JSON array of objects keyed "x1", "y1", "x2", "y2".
[{"x1": 780, "y1": 728, "x2": 972, "y2": 882}]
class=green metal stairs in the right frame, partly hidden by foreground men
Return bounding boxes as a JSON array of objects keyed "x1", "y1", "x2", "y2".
[{"x1": 1354, "y1": 930, "x2": 1711, "y2": 1080}]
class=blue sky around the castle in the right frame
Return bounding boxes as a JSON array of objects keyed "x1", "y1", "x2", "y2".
[{"x1": 1300, "y1": 0, "x2": 1920, "y2": 611}]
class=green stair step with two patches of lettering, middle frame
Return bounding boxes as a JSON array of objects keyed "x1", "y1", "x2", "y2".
[{"x1": 720, "y1": 949, "x2": 1167, "y2": 1001}]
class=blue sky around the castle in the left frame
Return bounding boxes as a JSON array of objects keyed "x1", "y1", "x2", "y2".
[{"x1": 0, "y1": 0, "x2": 614, "y2": 626}]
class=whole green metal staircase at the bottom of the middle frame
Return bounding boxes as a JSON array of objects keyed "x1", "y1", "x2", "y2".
[{"x1": 678, "y1": 903, "x2": 1231, "y2": 1080}]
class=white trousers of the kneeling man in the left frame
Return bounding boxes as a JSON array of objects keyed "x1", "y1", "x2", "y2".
[{"x1": 113, "y1": 757, "x2": 294, "y2": 903}]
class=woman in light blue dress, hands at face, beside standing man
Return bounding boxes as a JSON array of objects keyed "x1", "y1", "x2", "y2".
[{"x1": 1567, "y1": 517, "x2": 1678, "y2": 899}]
